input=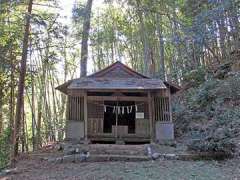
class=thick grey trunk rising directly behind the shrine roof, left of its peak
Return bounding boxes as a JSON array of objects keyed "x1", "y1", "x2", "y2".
[{"x1": 80, "y1": 0, "x2": 93, "y2": 77}]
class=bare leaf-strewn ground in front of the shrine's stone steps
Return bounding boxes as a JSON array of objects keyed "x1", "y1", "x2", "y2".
[{"x1": 0, "y1": 148, "x2": 240, "y2": 180}]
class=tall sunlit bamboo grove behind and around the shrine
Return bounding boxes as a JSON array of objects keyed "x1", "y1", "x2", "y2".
[{"x1": 0, "y1": 0, "x2": 240, "y2": 167}]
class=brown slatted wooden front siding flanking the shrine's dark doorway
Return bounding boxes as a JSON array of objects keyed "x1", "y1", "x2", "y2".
[{"x1": 67, "y1": 93, "x2": 172, "y2": 139}]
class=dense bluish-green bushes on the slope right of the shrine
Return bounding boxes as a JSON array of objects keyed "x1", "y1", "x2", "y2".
[{"x1": 174, "y1": 73, "x2": 240, "y2": 154}]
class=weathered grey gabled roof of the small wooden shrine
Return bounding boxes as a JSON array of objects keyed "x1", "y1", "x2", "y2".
[{"x1": 56, "y1": 61, "x2": 167, "y2": 94}]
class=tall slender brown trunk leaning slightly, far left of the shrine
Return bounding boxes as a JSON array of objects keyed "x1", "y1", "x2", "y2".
[{"x1": 12, "y1": 0, "x2": 33, "y2": 160}]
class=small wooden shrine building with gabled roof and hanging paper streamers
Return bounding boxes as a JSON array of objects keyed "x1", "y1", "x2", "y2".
[{"x1": 57, "y1": 62, "x2": 179, "y2": 142}]
